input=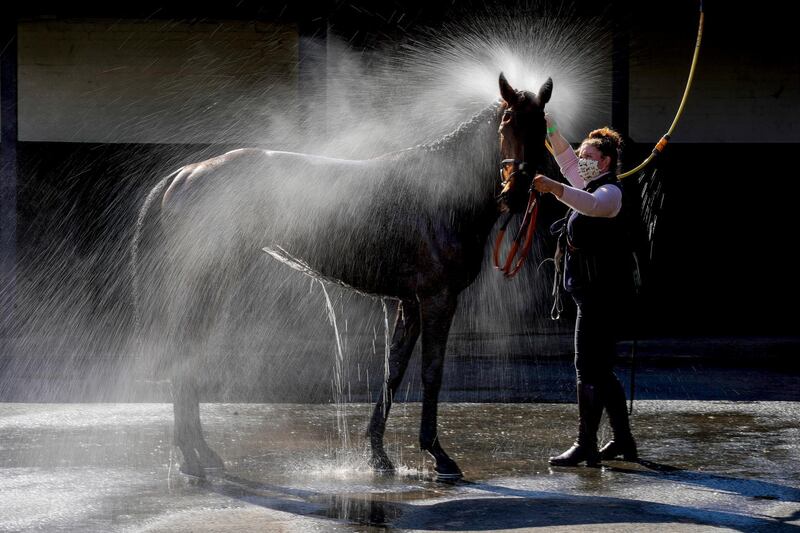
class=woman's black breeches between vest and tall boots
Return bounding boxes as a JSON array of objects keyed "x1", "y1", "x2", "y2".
[{"x1": 572, "y1": 291, "x2": 621, "y2": 385}]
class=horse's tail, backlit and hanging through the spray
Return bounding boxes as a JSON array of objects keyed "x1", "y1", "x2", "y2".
[{"x1": 130, "y1": 169, "x2": 181, "y2": 337}]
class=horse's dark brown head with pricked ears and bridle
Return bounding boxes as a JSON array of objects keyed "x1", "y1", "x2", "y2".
[{"x1": 498, "y1": 73, "x2": 553, "y2": 212}]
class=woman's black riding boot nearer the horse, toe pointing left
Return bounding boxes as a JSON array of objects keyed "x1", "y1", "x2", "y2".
[{"x1": 550, "y1": 381, "x2": 603, "y2": 466}]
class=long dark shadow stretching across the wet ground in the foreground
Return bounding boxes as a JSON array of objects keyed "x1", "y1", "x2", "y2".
[{"x1": 206, "y1": 470, "x2": 800, "y2": 532}]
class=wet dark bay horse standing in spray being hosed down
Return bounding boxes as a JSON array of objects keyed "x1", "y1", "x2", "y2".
[{"x1": 132, "y1": 74, "x2": 552, "y2": 479}]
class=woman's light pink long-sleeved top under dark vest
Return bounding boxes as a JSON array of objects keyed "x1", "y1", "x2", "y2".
[{"x1": 556, "y1": 148, "x2": 622, "y2": 218}]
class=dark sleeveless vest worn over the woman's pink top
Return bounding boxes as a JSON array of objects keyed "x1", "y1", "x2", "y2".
[{"x1": 561, "y1": 174, "x2": 632, "y2": 290}]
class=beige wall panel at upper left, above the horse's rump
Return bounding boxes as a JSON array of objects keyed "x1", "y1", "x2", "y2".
[{"x1": 19, "y1": 20, "x2": 298, "y2": 143}]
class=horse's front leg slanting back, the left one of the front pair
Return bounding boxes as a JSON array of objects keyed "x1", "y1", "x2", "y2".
[{"x1": 367, "y1": 300, "x2": 420, "y2": 472}]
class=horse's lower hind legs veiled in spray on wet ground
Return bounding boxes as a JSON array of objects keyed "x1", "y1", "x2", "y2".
[{"x1": 172, "y1": 376, "x2": 224, "y2": 477}]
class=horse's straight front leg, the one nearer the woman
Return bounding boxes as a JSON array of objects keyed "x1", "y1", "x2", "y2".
[{"x1": 419, "y1": 290, "x2": 463, "y2": 480}]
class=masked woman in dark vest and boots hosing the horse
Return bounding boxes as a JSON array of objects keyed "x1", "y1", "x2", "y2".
[{"x1": 533, "y1": 115, "x2": 638, "y2": 466}]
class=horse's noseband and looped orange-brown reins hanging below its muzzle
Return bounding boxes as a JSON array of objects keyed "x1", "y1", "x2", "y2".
[{"x1": 492, "y1": 159, "x2": 539, "y2": 278}]
